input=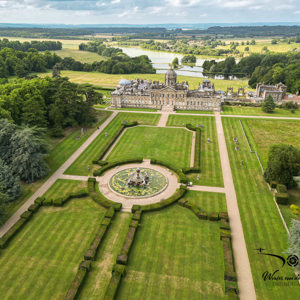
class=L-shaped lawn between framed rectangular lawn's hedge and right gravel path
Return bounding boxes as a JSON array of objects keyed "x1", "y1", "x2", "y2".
[{"x1": 167, "y1": 115, "x2": 223, "y2": 186}]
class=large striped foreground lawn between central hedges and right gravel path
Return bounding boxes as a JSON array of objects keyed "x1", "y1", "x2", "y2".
[{"x1": 117, "y1": 205, "x2": 227, "y2": 300}]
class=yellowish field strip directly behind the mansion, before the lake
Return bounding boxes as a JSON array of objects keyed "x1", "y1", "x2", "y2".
[{"x1": 37, "y1": 71, "x2": 250, "y2": 91}]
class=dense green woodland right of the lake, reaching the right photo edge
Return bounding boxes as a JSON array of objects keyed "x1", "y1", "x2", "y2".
[{"x1": 203, "y1": 53, "x2": 300, "y2": 93}]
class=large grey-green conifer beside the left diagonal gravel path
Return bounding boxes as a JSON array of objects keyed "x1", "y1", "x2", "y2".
[{"x1": 10, "y1": 127, "x2": 49, "y2": 183}]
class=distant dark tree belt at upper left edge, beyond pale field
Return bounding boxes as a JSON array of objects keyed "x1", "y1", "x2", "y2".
[{"x1": 0, "y1": 39, "x2": 62, "y2": 52}]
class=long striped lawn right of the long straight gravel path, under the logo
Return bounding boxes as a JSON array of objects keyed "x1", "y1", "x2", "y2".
[{"x1": 222, "y1": 118, "x2": 300, "y2": 299}]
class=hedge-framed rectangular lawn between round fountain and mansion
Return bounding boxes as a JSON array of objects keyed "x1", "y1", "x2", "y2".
[{"x1": 107, "y1": 127, "x2": 193, "y2": 168}]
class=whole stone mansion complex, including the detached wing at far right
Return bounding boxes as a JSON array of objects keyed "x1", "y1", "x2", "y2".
[{"x1": 111, "y1": 69, "x2": 286, "y2": 111}]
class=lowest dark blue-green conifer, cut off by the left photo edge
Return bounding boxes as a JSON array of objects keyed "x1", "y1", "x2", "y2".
[{"x1": 0, "y1": 158, "x2": 21, "y2": 203}]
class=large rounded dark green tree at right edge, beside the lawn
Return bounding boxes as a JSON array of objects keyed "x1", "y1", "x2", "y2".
[{"x1": 264, "y1": 144, "x2": 300, "y2": 187}]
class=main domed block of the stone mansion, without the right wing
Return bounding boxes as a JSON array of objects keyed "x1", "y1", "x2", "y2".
[{"x1": 111, "y1": 69, "x2": 223, "y2": 111}]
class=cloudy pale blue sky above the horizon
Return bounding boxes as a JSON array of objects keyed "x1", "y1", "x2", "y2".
[{"x1": 0, "y1": 0, "x2": 300, "y2": 24}]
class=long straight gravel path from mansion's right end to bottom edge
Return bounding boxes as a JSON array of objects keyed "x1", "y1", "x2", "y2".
[{"x1": 215, "y1": 112, "x2": 256, "y2": 300}]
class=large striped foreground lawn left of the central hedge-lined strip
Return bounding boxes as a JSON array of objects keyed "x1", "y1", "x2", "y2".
[{"x1": 0, "y1": 198, "x2": 106, "y2": 300}]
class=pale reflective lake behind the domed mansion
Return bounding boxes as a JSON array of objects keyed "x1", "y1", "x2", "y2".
[{"x1": 120, "y1": 47, "x2": 223, "y2": 78}]
